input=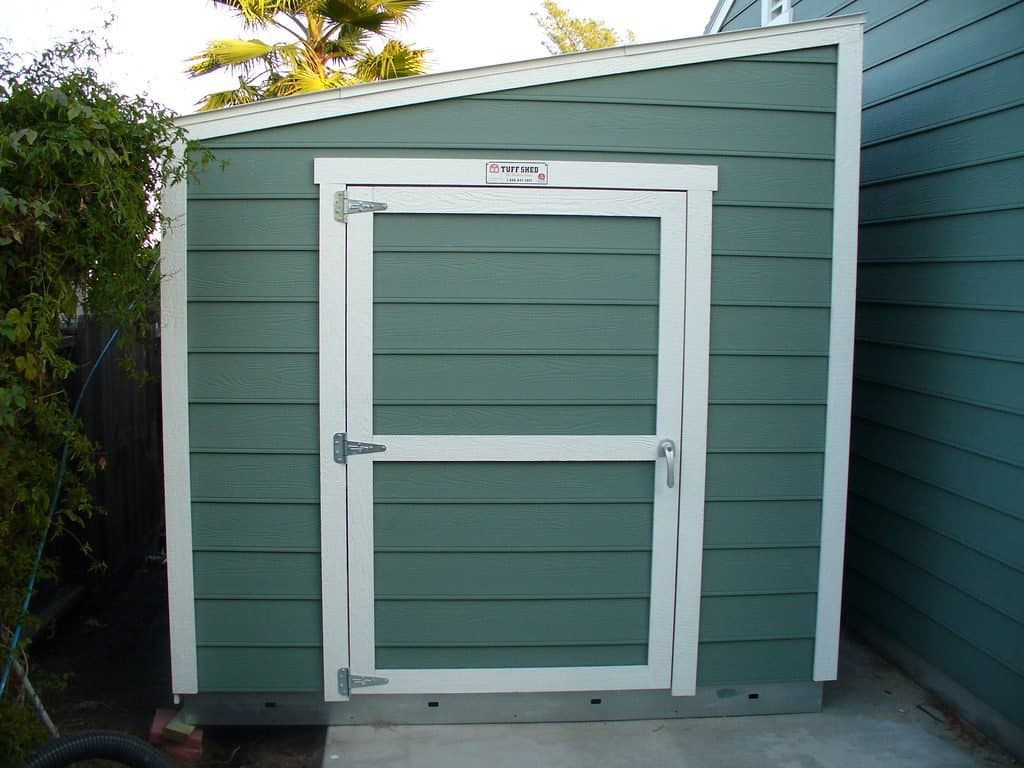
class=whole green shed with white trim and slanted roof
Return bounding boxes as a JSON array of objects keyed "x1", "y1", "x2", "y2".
[{"x1": 162, "y1": 17, "x2": 862, "y2": 724}]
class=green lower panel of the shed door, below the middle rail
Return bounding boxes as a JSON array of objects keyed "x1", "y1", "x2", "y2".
[{"x1": 374, "y1": 462, "x2": 653, "y2": 669}]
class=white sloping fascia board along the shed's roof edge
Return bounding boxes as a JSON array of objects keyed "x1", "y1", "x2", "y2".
[{"x1": 177, "y1": 14, "x2": 864, "y2": 140}]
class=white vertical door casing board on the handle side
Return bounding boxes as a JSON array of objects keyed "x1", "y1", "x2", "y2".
[{"x1": 672, "y1": 190, "x2": 712, "y2": 696}]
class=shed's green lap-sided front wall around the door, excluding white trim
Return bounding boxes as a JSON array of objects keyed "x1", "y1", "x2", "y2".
[{"x1": 187, "y1": 48, "x2": 836, "y2": 692}]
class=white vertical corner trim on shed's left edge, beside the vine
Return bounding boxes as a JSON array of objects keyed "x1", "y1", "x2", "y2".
[{"x1": 160, "y1": 144, "x2": 199, "y2": 694}]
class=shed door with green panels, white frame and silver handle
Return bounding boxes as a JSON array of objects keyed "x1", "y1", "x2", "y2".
[{"x1": 339, "y1": 186, "x2": 685, "y2": 695}]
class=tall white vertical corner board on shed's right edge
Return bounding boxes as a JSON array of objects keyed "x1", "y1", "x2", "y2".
[{"x1": 814, "y1": 26, "x2": 863, "y2": 681}]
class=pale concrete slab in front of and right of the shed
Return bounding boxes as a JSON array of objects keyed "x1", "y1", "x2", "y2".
[{"x1": 324, "y1": 636, "x2": 1017, "y2": 768}]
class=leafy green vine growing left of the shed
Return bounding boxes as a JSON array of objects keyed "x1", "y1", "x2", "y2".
[{"x1": 0, "y1": 40, "x2": 205, "y2": 765}]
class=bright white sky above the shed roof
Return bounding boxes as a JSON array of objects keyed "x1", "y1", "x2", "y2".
[{"x1": 0, "y1": 0, "x2": 715, "y2": 114}]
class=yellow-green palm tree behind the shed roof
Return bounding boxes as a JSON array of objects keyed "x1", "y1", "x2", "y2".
[{"x1": 187, "y1": 0, "x2": 427, "y2": 110}]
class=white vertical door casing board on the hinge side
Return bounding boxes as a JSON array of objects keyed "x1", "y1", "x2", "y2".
[{"x1": 317, "y1": 183, "x2": 350, "y2": 701}]
